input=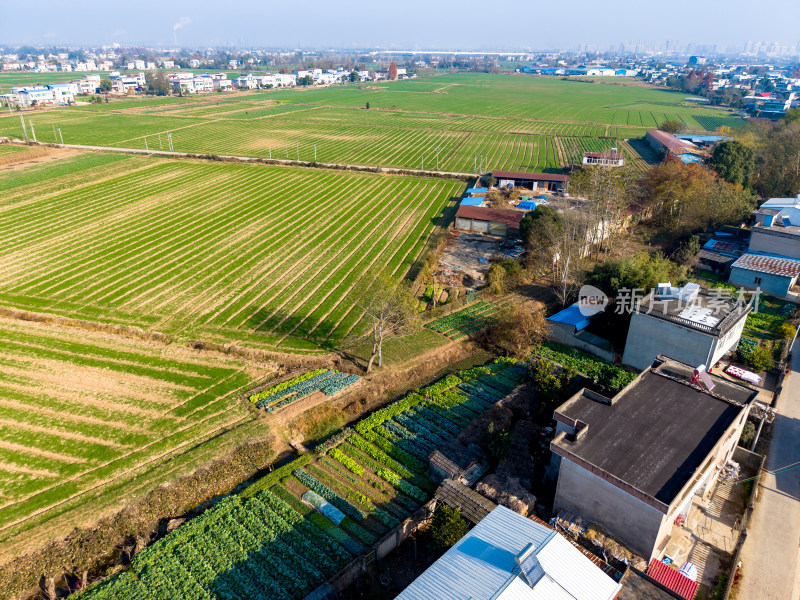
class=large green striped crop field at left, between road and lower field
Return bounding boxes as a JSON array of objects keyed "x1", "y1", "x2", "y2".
[{"x1": 0, "y1": 155, "x2": 464, "y2": 350}]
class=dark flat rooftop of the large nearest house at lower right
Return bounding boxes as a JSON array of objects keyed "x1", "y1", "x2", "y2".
[{"x1": 553, "y1": 360, "x2": 757, "y2": 506}]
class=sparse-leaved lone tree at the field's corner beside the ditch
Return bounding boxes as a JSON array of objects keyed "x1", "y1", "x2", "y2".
[{"x1": 355, "y1": 273, "x2": 417, "y2": 373}]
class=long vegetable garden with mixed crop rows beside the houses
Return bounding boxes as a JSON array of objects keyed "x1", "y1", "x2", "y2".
[{"x1": 77, "y1": 359, "x2": 525, "y2": 600}]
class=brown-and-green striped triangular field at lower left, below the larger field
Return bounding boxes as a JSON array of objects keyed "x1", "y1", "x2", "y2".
[{"x1": 0, "y1": 318, "x2": 269, "y2": 557}]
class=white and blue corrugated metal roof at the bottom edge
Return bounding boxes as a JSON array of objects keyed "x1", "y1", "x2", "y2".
[{"x1": 396, "y1": 506, "x2": 620, "y2": 600}]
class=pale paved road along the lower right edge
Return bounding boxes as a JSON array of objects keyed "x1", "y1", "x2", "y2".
[{"x1": 738, "y1": 350, "x2": 800, "y2": 600}]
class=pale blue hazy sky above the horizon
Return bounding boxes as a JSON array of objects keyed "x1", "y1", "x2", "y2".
[{"x1": 0, "y1": 0, "x2": 800, "y2": 50}]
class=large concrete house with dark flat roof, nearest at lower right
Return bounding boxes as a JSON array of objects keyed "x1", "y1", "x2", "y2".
[{"x1": 550, "y1": 356, "x2": 757, "y2": 560}]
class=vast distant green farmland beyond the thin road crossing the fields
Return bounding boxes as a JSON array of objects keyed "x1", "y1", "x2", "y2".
[{"x1": 0, "y1": 74, "x2": 745, "y2": 173}]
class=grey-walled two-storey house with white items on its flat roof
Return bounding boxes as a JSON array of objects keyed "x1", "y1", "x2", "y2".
[{"x1": 622, "y1": 282, "x2": 752, "y2": 369}]
